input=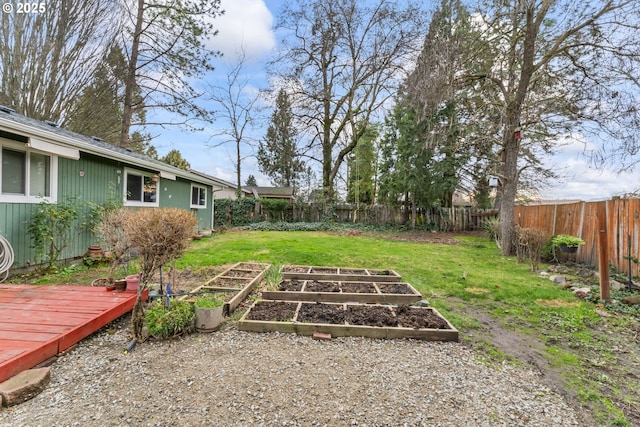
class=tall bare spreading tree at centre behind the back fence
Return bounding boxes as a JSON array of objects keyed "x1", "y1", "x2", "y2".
[{"x1": 275, "y1": 0, "x2": 424, "y2": 203}]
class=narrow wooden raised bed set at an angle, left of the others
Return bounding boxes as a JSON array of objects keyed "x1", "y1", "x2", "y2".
[{"x1": 180, "y1": 262, "x2": 271, "y2": 316}]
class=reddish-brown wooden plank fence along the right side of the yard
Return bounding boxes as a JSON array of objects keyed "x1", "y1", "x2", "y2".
[{"x1": 515, "y1": 198, "x2": 640, "y2": 275}]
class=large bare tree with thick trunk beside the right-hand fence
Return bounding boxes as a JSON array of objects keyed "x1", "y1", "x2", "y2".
[{"x1": 460, "y1": 0, "x2": 640, "y2": 254}]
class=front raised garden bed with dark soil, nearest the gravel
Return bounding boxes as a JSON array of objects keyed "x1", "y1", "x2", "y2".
[{"x1": 238, "y1": 300, "x2": 458, "y2": 341}]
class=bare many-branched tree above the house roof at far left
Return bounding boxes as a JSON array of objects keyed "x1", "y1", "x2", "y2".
[{"x1": 0, "y1": 0, "x2": 120, "y2": 122}]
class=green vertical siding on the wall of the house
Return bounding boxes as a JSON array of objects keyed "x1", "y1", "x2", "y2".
[{"x1": 0, "y1": 153, "x2": 213, "y2": 268}]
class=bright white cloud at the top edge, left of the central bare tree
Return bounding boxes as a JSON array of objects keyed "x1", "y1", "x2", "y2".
[{"x1": 208, "y1": 0, "x2": 276, "y2": 60}]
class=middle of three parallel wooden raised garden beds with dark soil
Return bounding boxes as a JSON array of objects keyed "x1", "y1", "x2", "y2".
[{"x1": 262, "y1": 279, "x2": 422, "y2": 304}]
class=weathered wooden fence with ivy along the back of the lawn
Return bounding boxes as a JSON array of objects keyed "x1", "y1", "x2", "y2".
[{"x1": 214, "y1": 198, "x2": 496, "y2": 231}]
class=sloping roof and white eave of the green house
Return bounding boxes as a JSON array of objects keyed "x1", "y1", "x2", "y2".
[{"x1": 0, "y1": 106, "x2": 224, "y2": 186}]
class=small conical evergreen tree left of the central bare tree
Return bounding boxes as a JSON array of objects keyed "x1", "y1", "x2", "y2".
[{"x1": 258, "y1": 89, "x2": 305, "y2": 187}]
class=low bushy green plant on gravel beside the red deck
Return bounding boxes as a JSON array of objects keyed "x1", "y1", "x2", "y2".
[{"x1": 145, "y1": 300, "x2": 195, "y2": 338}]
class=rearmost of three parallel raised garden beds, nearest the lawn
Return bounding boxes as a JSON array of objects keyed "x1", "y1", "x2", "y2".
[{"x1": 281, "y1": 265, "x2": 402, "y2": 282}]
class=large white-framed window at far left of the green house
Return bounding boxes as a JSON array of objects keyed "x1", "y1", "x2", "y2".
[{"x1": 0, "y1": 141, "x2": 57, "y2": 203}]
